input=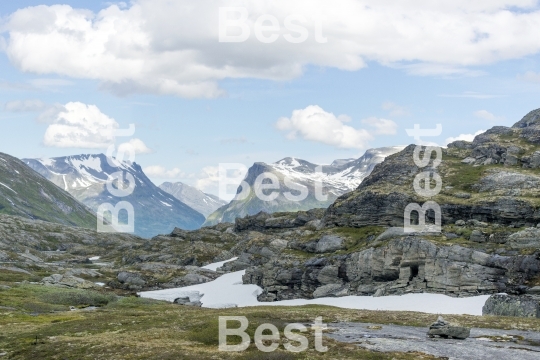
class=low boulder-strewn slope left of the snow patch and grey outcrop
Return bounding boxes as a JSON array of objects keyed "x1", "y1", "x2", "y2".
[{"x1": 0, "y1": 215, "x2": 236, "y2": 293}]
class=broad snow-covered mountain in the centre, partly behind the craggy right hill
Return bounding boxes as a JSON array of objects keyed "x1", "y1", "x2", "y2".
[{"x1": 203, "y1": 146, "x2": 404, "y2": 226}]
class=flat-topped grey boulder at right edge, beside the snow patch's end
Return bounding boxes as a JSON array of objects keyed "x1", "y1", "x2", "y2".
[{"x1": 482, "y1": 294, "x2": 540, "y2": 318}]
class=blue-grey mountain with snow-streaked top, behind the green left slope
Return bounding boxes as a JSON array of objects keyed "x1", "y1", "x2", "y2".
[{"x1": 23, "y1": 154, "x2": 204, "y2": 237}]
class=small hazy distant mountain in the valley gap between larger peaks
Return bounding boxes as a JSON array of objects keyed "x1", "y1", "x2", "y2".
[{"x1": 159, "y1": 182, "x2": 227, "y2": 216}]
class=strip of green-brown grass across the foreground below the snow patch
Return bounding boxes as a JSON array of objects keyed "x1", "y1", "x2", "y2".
[{"x1": 0, "y1": 285, "x2": 540, "y2": 360}]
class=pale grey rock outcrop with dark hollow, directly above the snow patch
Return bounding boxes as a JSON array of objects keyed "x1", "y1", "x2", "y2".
[{"x1": 243, "y1": 236, "x2": 540, "y2": 301}]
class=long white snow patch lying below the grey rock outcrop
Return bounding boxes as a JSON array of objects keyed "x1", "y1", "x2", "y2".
[{"x1": 139, "y1": 260, "x2": 489, "y2": 315}]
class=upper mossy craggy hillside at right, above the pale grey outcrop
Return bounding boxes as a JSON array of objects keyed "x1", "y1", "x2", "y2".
[{"x1": 323, "y1": 109, "x2": 540, "y2": 227}]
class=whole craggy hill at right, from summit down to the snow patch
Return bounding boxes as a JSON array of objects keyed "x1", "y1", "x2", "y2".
[{"x1": 236, "y1": 109, "x2": 540, "y2": 301}]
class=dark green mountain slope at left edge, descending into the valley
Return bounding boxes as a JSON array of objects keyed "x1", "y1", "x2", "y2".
[{"x1": 0, "y1": 153, "x2": 97, "y2": 229}]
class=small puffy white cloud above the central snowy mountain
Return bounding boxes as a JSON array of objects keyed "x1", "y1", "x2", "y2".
[{"x1": 276, "y1": 105, "x2": 397, "y2": 149}]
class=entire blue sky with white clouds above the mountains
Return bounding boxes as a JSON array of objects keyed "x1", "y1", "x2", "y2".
[{"x1": 0, "y1": 0, "x2": 540, "y2": 197}]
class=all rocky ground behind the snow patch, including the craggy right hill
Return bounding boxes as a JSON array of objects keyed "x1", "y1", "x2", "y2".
[{"x1": 0, "y1": 110, "x2": 540, "y2": 315}]
